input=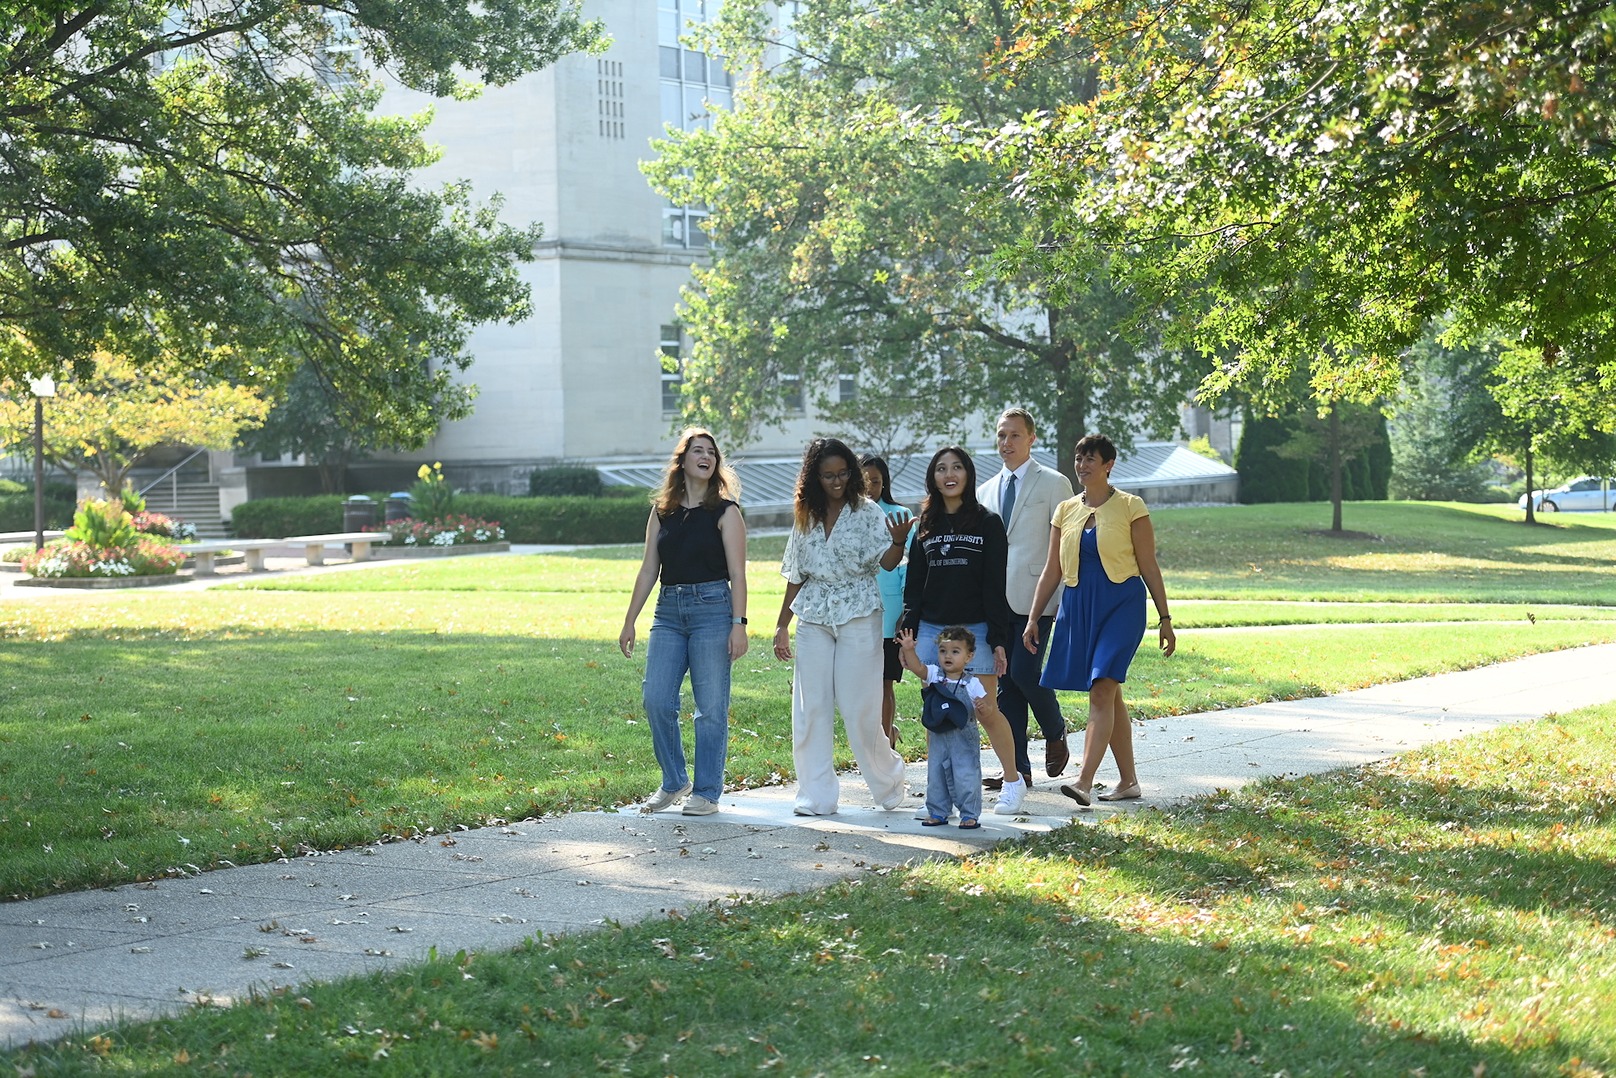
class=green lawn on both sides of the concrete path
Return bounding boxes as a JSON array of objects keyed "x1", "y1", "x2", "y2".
[{"x1": 0, "y1": 504, "x2": 1616, "y2": 1075}]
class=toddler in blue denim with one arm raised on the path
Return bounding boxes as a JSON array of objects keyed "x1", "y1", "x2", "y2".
[{"x1": 897, "y1": 625, "x2": 991, "y2": 831}]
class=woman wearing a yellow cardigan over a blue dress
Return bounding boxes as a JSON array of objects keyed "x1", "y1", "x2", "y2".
[{"x1": 1021, "y1": 435, "x2": 1178, "y2": 808}]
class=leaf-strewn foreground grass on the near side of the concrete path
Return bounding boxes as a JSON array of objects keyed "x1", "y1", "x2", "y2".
[{"x1": 0, "y1": 705, "x2": 1616, "y2": 1078}]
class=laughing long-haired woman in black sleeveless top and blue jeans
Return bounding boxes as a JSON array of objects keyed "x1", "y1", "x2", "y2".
[{"x1": 617, "y1": 427, "x2": 747, "y2": 816}]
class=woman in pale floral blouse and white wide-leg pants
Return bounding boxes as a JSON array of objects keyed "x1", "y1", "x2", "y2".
[{"x1": 774, "y1": 438, "x2": 913, "y2": 816}]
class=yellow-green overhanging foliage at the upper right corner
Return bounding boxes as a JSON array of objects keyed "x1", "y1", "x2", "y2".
[{"x1": 995, "y1": 0, "x2": 1616, "y2": 420}]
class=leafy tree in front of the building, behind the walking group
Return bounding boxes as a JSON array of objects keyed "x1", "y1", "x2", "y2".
[{"x1": 648, "y1": 0, "x2": 1197, "y2": 461}]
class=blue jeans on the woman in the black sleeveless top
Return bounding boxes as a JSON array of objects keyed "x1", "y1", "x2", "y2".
[{"x1": 643, "y1": 580, "x2": 732, "y2": 802}]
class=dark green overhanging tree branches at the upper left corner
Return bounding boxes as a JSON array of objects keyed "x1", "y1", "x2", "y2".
[{"x1": 0, "y1": 0, "x2": 598, "y2": 443}]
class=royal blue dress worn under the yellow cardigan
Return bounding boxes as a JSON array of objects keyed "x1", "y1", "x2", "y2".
[{"x1": 1039, "y1": 528, "x2": 1144, "y2": 692}]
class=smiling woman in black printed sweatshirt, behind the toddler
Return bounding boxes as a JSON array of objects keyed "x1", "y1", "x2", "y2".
[{"x1": 903, "y1": 446, "x2": 1028, "y2": 816}]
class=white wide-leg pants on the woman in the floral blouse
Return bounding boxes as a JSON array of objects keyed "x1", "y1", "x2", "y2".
[{"x1": 792, "y1": 611, "x2": 907, "y2": 816}]
